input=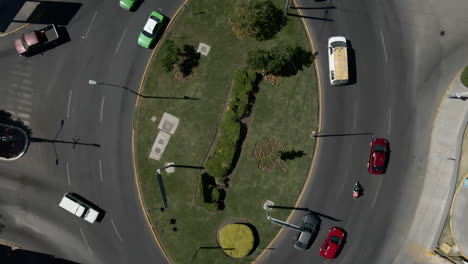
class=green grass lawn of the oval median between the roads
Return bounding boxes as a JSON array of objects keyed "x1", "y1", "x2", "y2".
[{"x1": 135, "y1": 0, "x2": 318, "y2": 263}]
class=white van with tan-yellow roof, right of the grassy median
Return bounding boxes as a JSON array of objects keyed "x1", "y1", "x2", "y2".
[{"x1": 328, "y1": 37, "x2": 349, "y2": 85}]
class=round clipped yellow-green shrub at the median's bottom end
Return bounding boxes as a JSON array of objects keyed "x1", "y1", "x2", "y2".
[{"x1": 219, "y1": 224, "x2": 255, "y2": 258}]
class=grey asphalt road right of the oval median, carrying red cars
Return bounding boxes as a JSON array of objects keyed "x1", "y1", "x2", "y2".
[{"x1": 259, "y1": 0, "x2": 468, "y2": 263}]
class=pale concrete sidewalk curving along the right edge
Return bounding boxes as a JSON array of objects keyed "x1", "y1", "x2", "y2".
[{"x1": 394, "y1": 73, "x2": 468, "y2": 264}]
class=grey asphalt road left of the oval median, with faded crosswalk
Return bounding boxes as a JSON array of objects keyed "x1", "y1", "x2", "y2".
[{"x1": 0, "y1": 0, "x2": 183, "y2": 263}]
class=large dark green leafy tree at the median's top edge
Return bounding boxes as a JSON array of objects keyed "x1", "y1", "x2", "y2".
[{"x1": 231, "y1": 0, "x2": 287, "y2": 41}]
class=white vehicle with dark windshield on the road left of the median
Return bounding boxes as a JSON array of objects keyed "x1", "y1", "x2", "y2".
[{"x1": 59, "y1": 193, "x2": 99, "y2": 224}]
